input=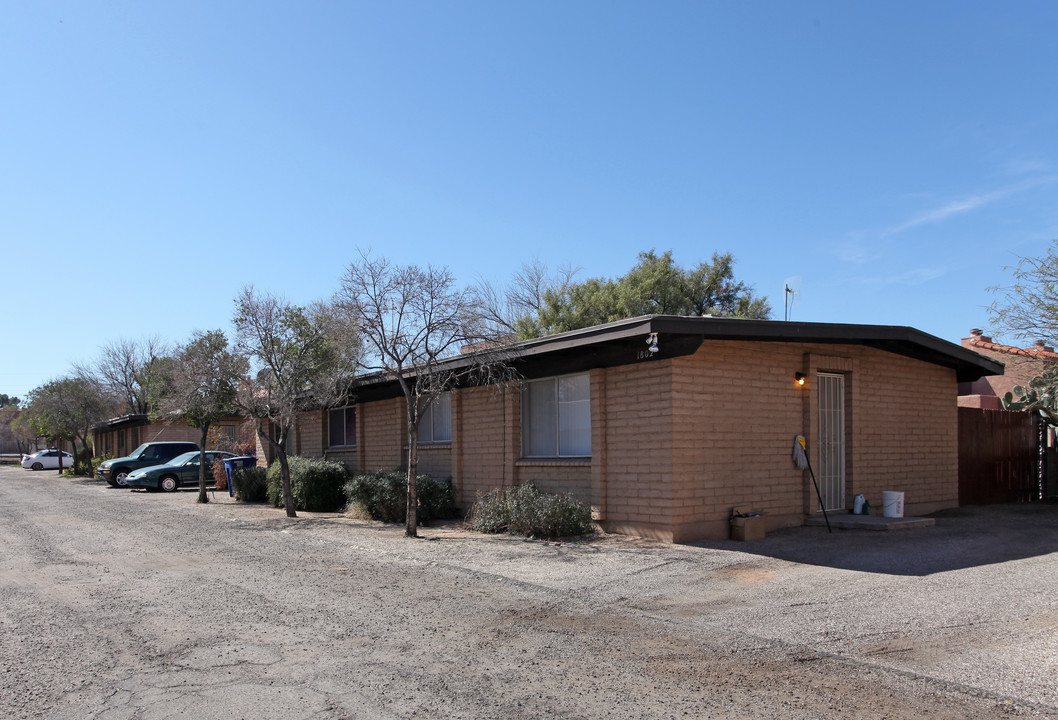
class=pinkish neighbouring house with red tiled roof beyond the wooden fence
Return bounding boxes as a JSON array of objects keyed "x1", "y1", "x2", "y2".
[{"x1": 959, "y1": 328, "x2": 1058, "y2": 410}]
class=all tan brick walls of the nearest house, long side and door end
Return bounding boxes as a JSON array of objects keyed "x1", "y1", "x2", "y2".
[{"x1": 285, "y1": 340, "x2": 957, "y2": 541}]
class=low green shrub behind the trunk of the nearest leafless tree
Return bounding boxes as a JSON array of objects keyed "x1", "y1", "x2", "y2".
[{"x1": 345, "y1": 470, "x2": 457, "y2": 523}]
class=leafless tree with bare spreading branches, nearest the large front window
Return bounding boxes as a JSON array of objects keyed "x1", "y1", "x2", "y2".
[{"x1": 335, "y1": 252, "x2": 501, "y2": 537}]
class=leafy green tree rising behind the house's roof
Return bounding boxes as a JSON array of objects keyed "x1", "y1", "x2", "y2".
[{"x1": 516, "y1": 250, "x2": 771, "y2": 337}]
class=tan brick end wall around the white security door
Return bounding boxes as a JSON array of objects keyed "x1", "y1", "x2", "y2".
[{"x1": 672, "y1": 341, "x2": 957, "y2": 540}]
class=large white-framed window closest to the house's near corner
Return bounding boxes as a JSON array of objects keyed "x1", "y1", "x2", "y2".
[{"x1": 522, "y1": 372, "x2": 591, "y2": 458}]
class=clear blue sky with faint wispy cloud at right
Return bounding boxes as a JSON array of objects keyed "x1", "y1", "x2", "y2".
[{"x1": 0, "y1": 0, "x2": 1058, "y2": 396}]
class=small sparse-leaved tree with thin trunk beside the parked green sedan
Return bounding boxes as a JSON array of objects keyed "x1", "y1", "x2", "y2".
[{"x1": 158, "y1": 330, "x2": 250, "y2": 502}]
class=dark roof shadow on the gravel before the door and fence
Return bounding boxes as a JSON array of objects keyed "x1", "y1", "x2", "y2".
[{"x1": 694, "y1": 503, "x2": 1058, "y2": 575}]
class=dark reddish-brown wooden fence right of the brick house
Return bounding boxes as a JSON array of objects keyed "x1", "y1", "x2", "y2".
[{"x1": 959, "y1": 407, "x2": 1042, "y2": 505}]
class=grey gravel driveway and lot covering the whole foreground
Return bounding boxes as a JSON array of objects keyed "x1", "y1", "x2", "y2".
[{"x1": 0, "y1": 467, "x2": 1058, "y2": 720}]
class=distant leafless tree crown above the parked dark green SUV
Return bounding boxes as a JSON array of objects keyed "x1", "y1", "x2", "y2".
[{"x1": 74, "y1": 337, "x2": 172, "y2": 414}]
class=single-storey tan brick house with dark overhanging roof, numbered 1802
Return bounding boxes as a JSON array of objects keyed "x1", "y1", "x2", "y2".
[{"x1": 275, "y1": 315, "x2": 1002, "y2": 542}]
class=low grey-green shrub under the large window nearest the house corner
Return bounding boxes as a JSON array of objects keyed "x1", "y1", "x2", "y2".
[{"x1": 469, "y1": 483, "x2": 595, "y2": 537}]
